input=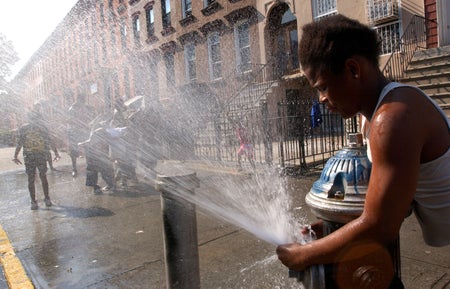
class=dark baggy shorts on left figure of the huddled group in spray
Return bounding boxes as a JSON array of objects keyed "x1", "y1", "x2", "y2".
[{"x1": 86, "y1": 157, "x2": 114, "y2": 187}]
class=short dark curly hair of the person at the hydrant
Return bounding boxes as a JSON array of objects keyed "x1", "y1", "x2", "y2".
[{"x1": 299, "y1": 14, "x2": 380, "y2": 74}]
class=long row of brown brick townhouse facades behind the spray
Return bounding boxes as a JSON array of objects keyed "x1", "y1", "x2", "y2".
[{"x1": 10, "y1": 0, "x2": 448, "y2": 156}]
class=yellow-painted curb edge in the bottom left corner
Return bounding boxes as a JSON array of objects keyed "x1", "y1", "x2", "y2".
[{"x1": 0, "y1": 225, "x2": 34, "y2": 289}]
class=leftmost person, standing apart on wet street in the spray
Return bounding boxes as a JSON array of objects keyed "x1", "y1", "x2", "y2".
[{"x1": 13, "y1": 110, "x2": 59, "y2": 210}]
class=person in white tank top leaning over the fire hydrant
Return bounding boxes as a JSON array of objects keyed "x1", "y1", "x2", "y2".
[{"x1": 276, "y1": 15, "x2": 450, "y2": 288}]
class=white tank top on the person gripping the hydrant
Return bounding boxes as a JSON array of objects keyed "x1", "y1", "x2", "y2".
[{"x1": 366, "y1": 82, "x2": 450, "y2": 246}]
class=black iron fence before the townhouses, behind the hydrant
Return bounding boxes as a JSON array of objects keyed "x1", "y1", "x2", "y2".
[{"x1": 190, "y1": 93, "x2": 352, "y2": 174}]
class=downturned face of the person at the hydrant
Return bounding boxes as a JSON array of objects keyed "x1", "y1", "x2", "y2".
[{"x1": 304, "y1": 68, "x2": 360, "y2": 118}]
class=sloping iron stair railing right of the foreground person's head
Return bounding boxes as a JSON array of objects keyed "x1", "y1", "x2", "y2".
[{"x1": 382, "y1": 15, "x2": 437, "y2": 81}]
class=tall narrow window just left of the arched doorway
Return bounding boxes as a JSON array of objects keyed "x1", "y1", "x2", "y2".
[{"x1": 234, "y1": 22, "x2": 251, "y2": 73}]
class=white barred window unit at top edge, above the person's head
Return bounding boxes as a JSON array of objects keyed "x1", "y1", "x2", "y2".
[{"x1": 367, "y1": 0, "x2": 398, "y2": 24}]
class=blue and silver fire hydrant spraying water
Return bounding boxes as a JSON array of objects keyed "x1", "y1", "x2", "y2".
[{"x1": 298, "y1": 133, "x2": 400, "y2": 289}]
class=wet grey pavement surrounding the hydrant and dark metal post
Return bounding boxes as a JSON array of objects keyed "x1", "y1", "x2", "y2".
[{"x1": 0, "y1": 148, "x2": 450, "y2": 289}]
